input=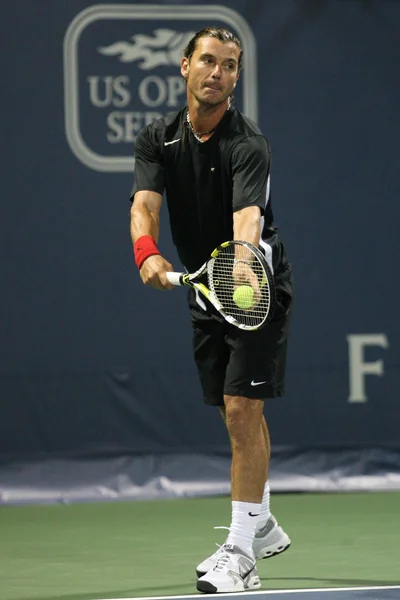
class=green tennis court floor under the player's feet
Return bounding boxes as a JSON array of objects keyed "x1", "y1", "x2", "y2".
[{"x1": 0, "y1": 492, "x2": 400, "y2": 600}]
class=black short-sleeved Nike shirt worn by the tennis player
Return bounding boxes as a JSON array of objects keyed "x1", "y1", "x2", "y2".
[{"x1": 131, "y1": 108, "x2": 286, "y2": 272}]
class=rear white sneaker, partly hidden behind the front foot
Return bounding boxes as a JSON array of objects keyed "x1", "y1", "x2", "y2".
[{"x1": 196, "y1": 515, "x2": 290, "y2": 577}]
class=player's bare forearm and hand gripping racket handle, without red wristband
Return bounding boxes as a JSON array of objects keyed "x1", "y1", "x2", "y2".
[{"x1": 130, "y1": 190, "x2": 173, "y2": 290}]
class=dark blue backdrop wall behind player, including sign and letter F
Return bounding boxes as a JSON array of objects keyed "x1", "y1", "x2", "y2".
[{"x1": 0, "y1": 0, "x2": 400, "y2": 501}]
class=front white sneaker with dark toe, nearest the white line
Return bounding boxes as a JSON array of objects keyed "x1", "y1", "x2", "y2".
[{"x1": 196, "y1": 544, "x2": 261, "y2": 594}]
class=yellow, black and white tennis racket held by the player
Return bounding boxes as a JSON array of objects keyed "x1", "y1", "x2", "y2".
[{"x1": 166, "y1": 240, "x2": 275, "y2": 331}]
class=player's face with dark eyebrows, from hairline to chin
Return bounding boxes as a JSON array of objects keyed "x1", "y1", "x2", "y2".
[{"x1": 181, "y1": 37, "x2": 240, "y2": 106}]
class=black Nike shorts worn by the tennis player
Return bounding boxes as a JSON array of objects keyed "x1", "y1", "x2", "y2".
[{"x1": 189, "y1": 264, "x2": 293, "y2": 406}]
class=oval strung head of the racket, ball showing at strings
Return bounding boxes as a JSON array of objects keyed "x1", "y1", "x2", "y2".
[{"x1": 209, "y1": 244, "x2": 271, "y2": 327}]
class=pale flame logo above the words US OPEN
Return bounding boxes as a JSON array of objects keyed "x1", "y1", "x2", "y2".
[{"x1": 98, "y1": 29, "x2": 195, "y2": 71}]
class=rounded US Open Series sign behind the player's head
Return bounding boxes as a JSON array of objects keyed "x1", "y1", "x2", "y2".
[{"x1": 64, "y1": 4, "x2": 258, "y2": 172}]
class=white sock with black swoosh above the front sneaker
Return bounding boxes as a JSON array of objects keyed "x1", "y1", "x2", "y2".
[{"x1": 225, "y1": 500, "x2": 261, "y2": 556}]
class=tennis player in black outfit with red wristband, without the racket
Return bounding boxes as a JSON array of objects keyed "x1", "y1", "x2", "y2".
[{"x1": 131, "y1": 27, "x2": 293, "y2": 593}]
